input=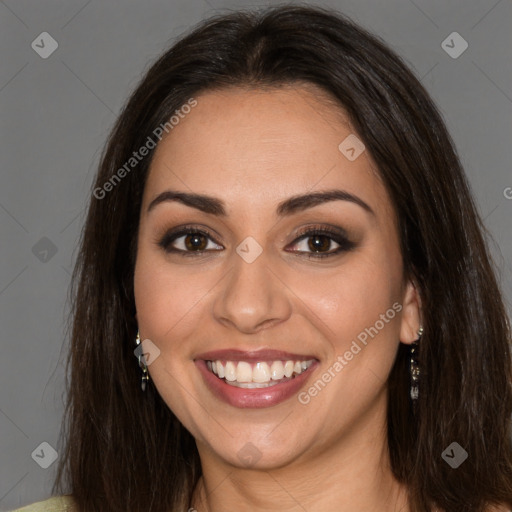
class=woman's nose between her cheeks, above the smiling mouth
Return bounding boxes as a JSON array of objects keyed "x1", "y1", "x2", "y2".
[{"x1": 213, "y1": 251, "x2": 292, "y2": 334}]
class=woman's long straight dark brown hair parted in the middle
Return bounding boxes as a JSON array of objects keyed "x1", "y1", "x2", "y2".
[{"x1": 54, "y1": 6, "x2": 512, "y2": 512}]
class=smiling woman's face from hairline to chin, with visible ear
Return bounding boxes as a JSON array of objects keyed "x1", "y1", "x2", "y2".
[{"x1": 135, "y1": 86, "x2": 419, "y2": 468}]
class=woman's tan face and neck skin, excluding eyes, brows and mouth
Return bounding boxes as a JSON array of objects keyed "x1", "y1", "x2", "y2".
[{"x1": 135, "y1": 85, "x2": 421, "y2": 512}]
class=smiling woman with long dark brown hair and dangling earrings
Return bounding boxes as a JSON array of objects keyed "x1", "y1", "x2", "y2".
[{"x1": 15, "y1": 6, "x2": 512, "y2": 512}]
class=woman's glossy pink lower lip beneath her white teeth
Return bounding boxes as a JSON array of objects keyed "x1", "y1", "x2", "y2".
[{"x1": 195, "y1": 360, "x2": 318, "y2": 409}]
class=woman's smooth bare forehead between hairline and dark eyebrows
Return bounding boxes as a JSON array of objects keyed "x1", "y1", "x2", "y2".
[{"x1": 144, "y1": 86, "x2": 390, "y2": 214}]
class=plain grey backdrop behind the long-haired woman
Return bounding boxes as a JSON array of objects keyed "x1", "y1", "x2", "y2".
[{"x1": 0, "y1": 0, "x2": 512, "y2": 510}]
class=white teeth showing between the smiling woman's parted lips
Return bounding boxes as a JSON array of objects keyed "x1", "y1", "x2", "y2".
[{"x1": 206, "y1": 359, "x2": 315, "y2": 389}]
